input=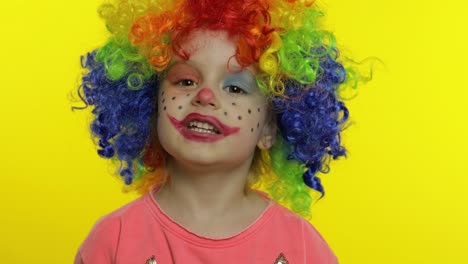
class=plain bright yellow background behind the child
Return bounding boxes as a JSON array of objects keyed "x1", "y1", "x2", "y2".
[{"x1": 0, "y1": 0, "x2": 468, "y2": 264}]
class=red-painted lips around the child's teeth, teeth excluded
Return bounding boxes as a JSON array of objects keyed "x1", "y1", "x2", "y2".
[{"x1": 167, "y1": 113, "x2": 240, "y2": 142}]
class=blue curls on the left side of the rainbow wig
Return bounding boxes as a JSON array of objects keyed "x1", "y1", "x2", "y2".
[{"x1": 79, "y1": 51, "x2": 158, "y2": 185}]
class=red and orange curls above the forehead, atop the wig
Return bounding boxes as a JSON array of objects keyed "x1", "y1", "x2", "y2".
[{"x1": 129, "y1": 0, "x2": 279, "y2": 71}]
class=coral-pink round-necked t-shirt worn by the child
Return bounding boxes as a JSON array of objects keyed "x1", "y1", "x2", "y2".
[{"x1": 75, "y1": 187, "x2": 338, "y2": 264}]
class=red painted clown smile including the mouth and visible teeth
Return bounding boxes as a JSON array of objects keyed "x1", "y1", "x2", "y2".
[{"x1": 167, "y1": 113, "x2": 240, "y2": 142}]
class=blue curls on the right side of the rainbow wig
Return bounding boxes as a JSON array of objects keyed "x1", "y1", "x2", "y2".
[{"x1": 272, "y1": 52, "x2": 349, "y2": 196}]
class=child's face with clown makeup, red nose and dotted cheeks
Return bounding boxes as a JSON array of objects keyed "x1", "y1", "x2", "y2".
[{"x1": 157, "y1": 31, "x2": 272, "y2": 166}]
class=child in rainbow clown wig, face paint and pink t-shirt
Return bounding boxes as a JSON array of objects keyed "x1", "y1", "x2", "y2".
[{"x1": 75, "y1": 0, "x2": 348, "y2": 264}]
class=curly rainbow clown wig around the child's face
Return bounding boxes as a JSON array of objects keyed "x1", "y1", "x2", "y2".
[{"x1": 78, "y1": 0, "x2": 353, "y2": 218}]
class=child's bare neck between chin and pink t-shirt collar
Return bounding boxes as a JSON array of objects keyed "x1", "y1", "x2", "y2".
[{"x1": 158, "y1": 157, "x2": 251, "y2": 219}]
